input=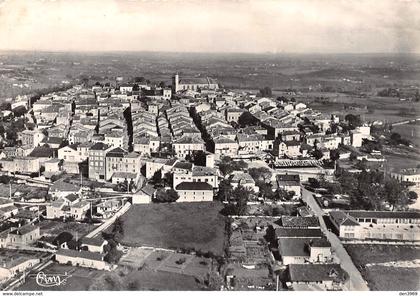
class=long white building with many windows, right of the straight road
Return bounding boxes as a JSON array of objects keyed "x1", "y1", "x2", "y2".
[{"x1": 330, "y1": 211, "x2": 420, "y2": 241}]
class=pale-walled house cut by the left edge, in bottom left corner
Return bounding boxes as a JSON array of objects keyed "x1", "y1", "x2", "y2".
[{"x1": 0, "y1": 257, "x2": 40, "y2": 282}]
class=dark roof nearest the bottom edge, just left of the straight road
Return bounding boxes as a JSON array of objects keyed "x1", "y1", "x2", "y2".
[{"x1": 289, "y1": 264, "x2": 346, "y2": 282}]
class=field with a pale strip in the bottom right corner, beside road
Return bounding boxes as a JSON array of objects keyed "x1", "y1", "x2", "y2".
[{"x1": 345, "y1": 244, "x2": 420, "y2": 291}]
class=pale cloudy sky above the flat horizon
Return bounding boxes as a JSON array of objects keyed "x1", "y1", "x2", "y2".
[{"x1": 0, "y1": 0, "x2": 420, "y2": 53}]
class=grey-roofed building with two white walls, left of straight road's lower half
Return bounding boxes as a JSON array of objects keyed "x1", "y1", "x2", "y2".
[{"x1": 278, "y1": 237, "x2": 332, "y2": 265}]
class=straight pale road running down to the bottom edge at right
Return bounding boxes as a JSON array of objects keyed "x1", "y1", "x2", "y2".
[{"x1": 302, "y1": 187, "x2": 369, "y2": 291}]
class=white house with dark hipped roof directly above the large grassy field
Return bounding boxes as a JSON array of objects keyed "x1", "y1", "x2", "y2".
[{"x1": 175, "y1": 182, "x2": 213, "y2": 202}]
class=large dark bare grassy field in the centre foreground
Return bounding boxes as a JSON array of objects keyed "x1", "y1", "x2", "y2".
[{"x1": 116, "y1": 202, "x2": 225, "y2": 255}]
